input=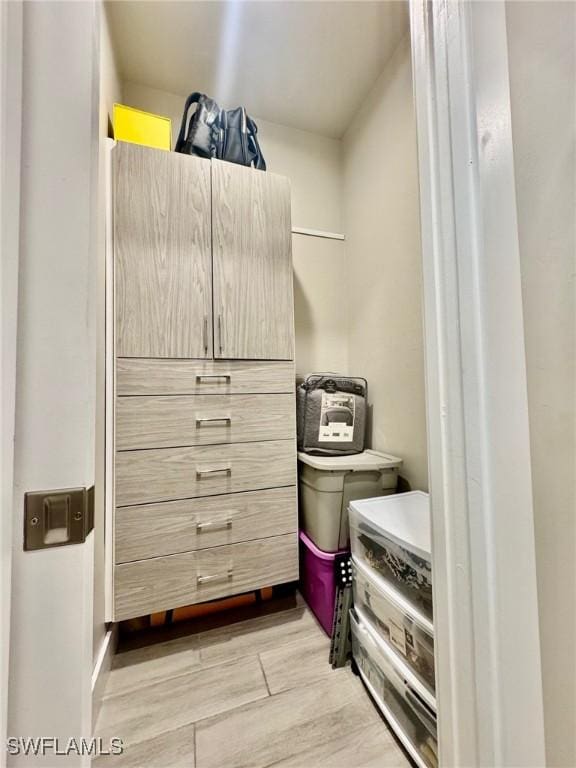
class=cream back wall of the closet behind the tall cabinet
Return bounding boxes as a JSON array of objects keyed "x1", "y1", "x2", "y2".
[{"x1": 122, "y1": 82, "x2": 348, "y2": 374}]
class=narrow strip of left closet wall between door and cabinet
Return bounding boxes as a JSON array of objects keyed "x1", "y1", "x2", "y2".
[{"x1": 93, "y1": 4, "x2": 122, "y2": 662}]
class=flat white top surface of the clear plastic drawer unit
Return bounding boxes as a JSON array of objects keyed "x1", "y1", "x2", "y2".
[{"x1": 350, "y1": 491, "x2": 431, "y2": 560}]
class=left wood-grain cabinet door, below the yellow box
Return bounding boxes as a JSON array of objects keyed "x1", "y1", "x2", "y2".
[{"x1": 113, "y1": 143, "x2": 212, "y2": 358}]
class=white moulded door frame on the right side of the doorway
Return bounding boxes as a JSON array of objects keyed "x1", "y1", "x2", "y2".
[{"x1": 410, "y1": 0, "x2": 545, "y2": 768}]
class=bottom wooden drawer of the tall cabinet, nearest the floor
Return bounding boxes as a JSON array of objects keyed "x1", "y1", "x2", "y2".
[{"x1": 114, "y1": 533, "x2": 298, "y2": 621}]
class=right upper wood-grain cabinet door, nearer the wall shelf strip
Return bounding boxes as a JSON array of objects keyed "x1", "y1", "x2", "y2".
[{"x1": 212, "y1": 160, "x2": 294, "y2": 360}]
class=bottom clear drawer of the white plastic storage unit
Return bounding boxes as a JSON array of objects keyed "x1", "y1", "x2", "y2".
[{"x1": 350, "y1": 609, "x2": 438, "y2": 768}]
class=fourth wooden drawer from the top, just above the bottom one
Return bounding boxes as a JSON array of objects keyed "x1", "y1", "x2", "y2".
[{"x1": 115, "y1": 486, "x2": 298, "y2": 563}]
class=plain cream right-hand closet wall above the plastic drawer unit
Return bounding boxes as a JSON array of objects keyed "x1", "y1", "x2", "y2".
[{"x1": 343, "y1": 37, "x2": 428, "y2": 490}]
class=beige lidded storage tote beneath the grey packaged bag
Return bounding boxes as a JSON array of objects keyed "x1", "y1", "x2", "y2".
[{"x1": 298, "y1": 451, "x2": 402, "y2": 552}]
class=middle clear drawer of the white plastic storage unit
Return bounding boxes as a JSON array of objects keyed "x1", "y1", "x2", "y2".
[{"x1": 352, "y1": 560, "x2": 436, "y2": 693}]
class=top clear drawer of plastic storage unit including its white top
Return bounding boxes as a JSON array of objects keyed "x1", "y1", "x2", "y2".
[{"x1": 349, "y1": 491, "x2": 433, "y2": 621}]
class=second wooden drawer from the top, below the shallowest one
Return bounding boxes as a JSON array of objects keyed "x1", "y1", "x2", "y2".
[{"x1": 116, "y1": 394, "x2": 296, "y2": 451}]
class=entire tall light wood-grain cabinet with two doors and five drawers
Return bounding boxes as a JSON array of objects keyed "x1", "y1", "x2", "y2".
[{"x1": 112, "y1": 143, "x2": 298, "y2": 621}]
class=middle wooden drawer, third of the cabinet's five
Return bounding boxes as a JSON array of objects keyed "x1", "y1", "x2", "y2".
[{"x1": 116, "y1": 440, "x2": 296, "y2": 506}]
